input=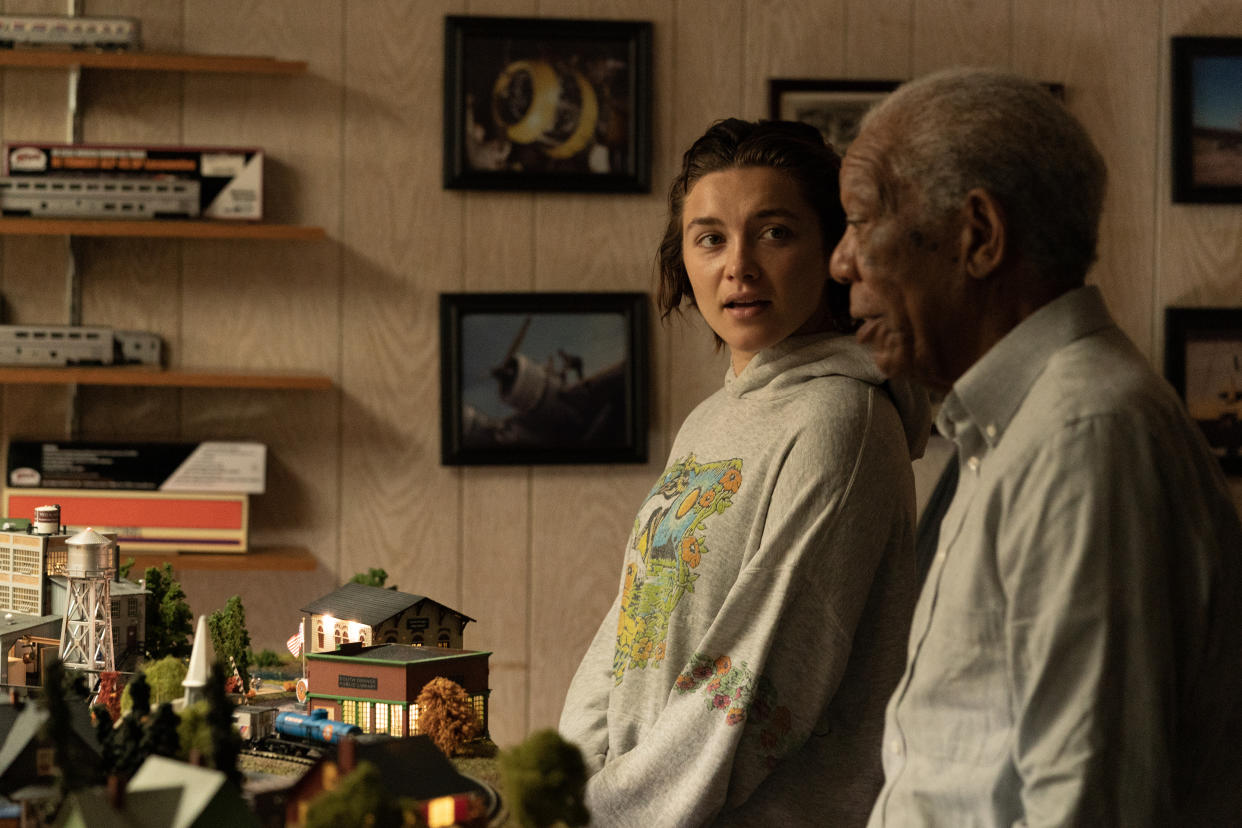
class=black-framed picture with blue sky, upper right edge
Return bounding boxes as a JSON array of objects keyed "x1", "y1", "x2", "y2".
[{"x1": 1170, "y1": 36, "x2": 1242, "y2": 204}]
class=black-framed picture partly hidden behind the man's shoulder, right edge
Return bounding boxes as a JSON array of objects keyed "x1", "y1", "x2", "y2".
[{"x1": 1165, "y1": 308, "x2": 1242, "y2": 474}]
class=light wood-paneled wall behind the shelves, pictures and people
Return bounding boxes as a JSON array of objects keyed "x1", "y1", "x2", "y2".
[{"x1": 0, "y1": 0, "x2": 1242, "y2": 745}]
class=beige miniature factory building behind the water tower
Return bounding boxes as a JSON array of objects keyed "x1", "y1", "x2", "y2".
[{"x1": 0, "y1": 521, "x2": 147, "y2": 685}]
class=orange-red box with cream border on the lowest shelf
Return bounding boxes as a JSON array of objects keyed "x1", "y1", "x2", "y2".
[{"x1": 4, "y1": 488, "x2": 250, "y2": 554}]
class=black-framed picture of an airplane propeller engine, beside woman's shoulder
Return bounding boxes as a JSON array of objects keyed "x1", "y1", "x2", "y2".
[{"x1": 440, "y1": 293, "x2": 648, "y2": 466}]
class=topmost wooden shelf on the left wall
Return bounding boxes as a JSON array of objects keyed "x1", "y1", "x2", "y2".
[{"x1": 0, "y1": 48, "x2": 307, "y2": 74}]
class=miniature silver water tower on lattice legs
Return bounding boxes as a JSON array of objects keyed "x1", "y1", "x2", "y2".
[{"x1": 61, "y1": 529, "x2": 116, "y2": 672}]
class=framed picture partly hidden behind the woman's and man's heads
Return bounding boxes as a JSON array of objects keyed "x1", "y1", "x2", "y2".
[{"x1": 768, "y1": 78, "x2": 900, "y2": 155}]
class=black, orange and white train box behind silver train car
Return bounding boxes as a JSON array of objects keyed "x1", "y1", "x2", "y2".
[{"x1": 4, "y1": 142, "x2": 263, "y2": 221}]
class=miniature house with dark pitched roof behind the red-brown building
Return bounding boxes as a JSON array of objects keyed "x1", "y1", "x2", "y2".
[{"x1": 302, "y1": 583, "x2": 474, "y2": 653}]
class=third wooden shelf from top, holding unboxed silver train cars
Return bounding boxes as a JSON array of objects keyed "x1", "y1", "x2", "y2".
[{"x1": 0, "y1": 365, "x2": 332, "y2": 391}]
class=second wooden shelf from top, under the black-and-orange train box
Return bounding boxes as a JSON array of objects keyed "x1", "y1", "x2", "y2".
[{"x1": 0, "y1": 218, "x2": 325, "y2": 241}]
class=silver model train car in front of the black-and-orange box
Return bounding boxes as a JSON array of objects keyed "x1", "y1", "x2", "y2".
[{"x1": 0, "y1": 175, "x2": 200, "y2": 218}]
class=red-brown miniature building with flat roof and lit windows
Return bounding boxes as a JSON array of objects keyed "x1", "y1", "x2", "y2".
[{"x1": 307, "y1": 643, "x2": 491, "y2": 736}]
